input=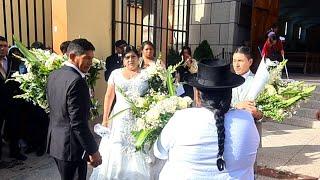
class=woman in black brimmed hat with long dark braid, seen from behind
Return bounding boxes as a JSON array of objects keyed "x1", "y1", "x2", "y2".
[{"x1": 154, "y1": 59, "x2": 259, "y2": 180}]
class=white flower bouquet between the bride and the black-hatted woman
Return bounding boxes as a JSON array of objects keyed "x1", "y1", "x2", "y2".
[{"x1": 124, "y1": 56, "x2": 192, "y2": 150}]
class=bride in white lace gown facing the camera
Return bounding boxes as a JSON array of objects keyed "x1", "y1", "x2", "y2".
[{"x1": 90, "y1": 46, "x2": 150, "y2": 180}]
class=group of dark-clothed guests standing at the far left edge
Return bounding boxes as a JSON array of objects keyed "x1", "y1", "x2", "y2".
[{"x1": 0, "y1": 36, "x2": 49, "y2": 162}]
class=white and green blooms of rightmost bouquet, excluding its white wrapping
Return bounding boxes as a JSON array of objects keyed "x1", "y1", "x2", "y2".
[{"x1": 256, "y1": 60, "x2": 316, "y2": 122}]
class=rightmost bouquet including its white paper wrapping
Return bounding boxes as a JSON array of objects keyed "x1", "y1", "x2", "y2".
[{"x1": 248, "y1": 59, "x2": 316, "y2": 122}]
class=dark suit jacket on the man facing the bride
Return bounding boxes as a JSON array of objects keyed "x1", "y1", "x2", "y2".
[{"x1": 47, "y1": 66, "x2": 98, "y2": 161}]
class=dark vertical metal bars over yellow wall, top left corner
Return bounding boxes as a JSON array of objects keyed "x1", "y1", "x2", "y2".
[{"x1": 0, "y1": 0, "x2": 52, "y2": 47}]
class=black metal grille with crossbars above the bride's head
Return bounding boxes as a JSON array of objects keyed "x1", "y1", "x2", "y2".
[{"x1": 112, "y1": 0, "x2": 190, "y2": 60}]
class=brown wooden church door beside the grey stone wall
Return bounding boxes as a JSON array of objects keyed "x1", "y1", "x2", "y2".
[{"x1": 251, "y1": 0, "x2": 280, "y2": 71}]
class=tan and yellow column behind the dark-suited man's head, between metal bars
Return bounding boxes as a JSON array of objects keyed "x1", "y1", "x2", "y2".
[{"x1": 52, "y1": 0, "x2": 112, "y2": 106}]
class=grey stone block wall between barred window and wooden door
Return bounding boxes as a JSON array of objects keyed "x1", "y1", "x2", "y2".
[{"x1": 189, "y1": 0, "x2": 244, "y2": 55}]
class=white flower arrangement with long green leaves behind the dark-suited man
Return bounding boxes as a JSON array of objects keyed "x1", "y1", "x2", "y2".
[{"x1": 12, "y1": 37, "x2": 104, "y2": 119}]
